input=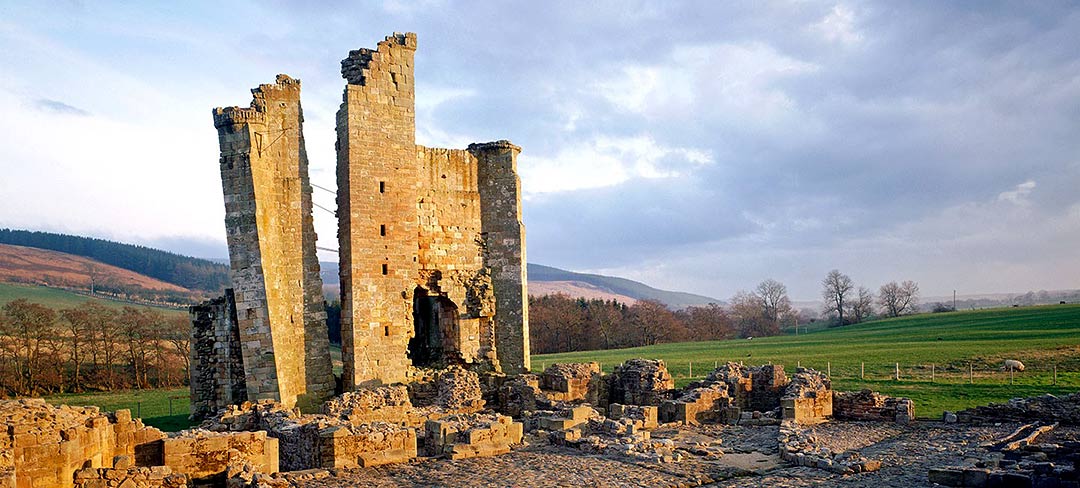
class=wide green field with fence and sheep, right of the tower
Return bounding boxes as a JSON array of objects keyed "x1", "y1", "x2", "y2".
[{"x1": 532, "y1": 304, "x2": 1080, "y2": 417}]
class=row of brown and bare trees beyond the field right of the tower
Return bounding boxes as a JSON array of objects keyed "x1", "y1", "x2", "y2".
[{"x1": 529, "y1": 270, "x2": 919, "y2": 354}]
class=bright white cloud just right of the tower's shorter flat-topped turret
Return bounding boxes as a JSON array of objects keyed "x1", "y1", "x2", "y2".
[{"x1": 518, "y1": 135, "x2": 713, "y2": 194}]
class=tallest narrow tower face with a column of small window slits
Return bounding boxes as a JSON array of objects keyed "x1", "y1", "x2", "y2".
[{"x1": 337, "y1": 33, "x2": 418, "y2": 390}]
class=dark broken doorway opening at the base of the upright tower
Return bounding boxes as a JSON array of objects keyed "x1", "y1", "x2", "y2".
[{"x1": 408, "y1": 286, "x2": 458, "y2": 367}]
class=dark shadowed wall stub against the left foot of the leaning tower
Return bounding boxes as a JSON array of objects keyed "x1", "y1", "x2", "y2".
[{"x1": 189, "y1": 289, "x2": 247, "y2": 419}]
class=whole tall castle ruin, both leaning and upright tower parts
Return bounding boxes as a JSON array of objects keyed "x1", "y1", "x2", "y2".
[{"x1": 191, "y1": 33, "x2": 529, "y2": 417}]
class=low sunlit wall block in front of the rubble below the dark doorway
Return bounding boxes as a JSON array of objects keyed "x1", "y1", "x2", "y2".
[{"x1": 424, "y1": 414, "x2": 525, "y2": 459}]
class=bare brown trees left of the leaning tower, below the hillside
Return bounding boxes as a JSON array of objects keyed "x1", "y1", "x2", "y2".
[{"x1": 0, "y1": 299, "x2": 190, "y2": 396}]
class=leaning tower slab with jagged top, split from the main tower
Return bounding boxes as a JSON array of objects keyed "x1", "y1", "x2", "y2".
[{"x1": 214, "y1": 74, "x2": 334, "y2": 406}]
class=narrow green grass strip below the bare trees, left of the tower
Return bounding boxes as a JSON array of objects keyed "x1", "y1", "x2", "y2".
[{"x1": 45, "y1": 388, "x2": 191, "y2": 432}]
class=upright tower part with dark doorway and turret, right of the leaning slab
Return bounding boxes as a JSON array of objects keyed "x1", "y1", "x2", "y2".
[{"x1": 337, "y1": 33, "x2": 528, "y2": 390}]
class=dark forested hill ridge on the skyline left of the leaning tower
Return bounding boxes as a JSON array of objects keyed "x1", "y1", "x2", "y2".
[{"x1": 0, "y1": 229, "x2": 229, "y2": 293}]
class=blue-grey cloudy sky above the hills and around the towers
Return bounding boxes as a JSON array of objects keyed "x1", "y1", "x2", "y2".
[{"x1": 0, "y1": 1, "x2": 1080, "y2": 299}]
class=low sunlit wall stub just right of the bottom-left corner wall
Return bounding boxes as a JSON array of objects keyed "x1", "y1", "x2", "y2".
[{"x1": 162, "y1": 430, "x2": 279, "y2": 482}]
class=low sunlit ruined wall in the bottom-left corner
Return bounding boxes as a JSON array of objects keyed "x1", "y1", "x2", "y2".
[{"x1": 0, "y1": 398, "x2": 163, "y2": 488}]
